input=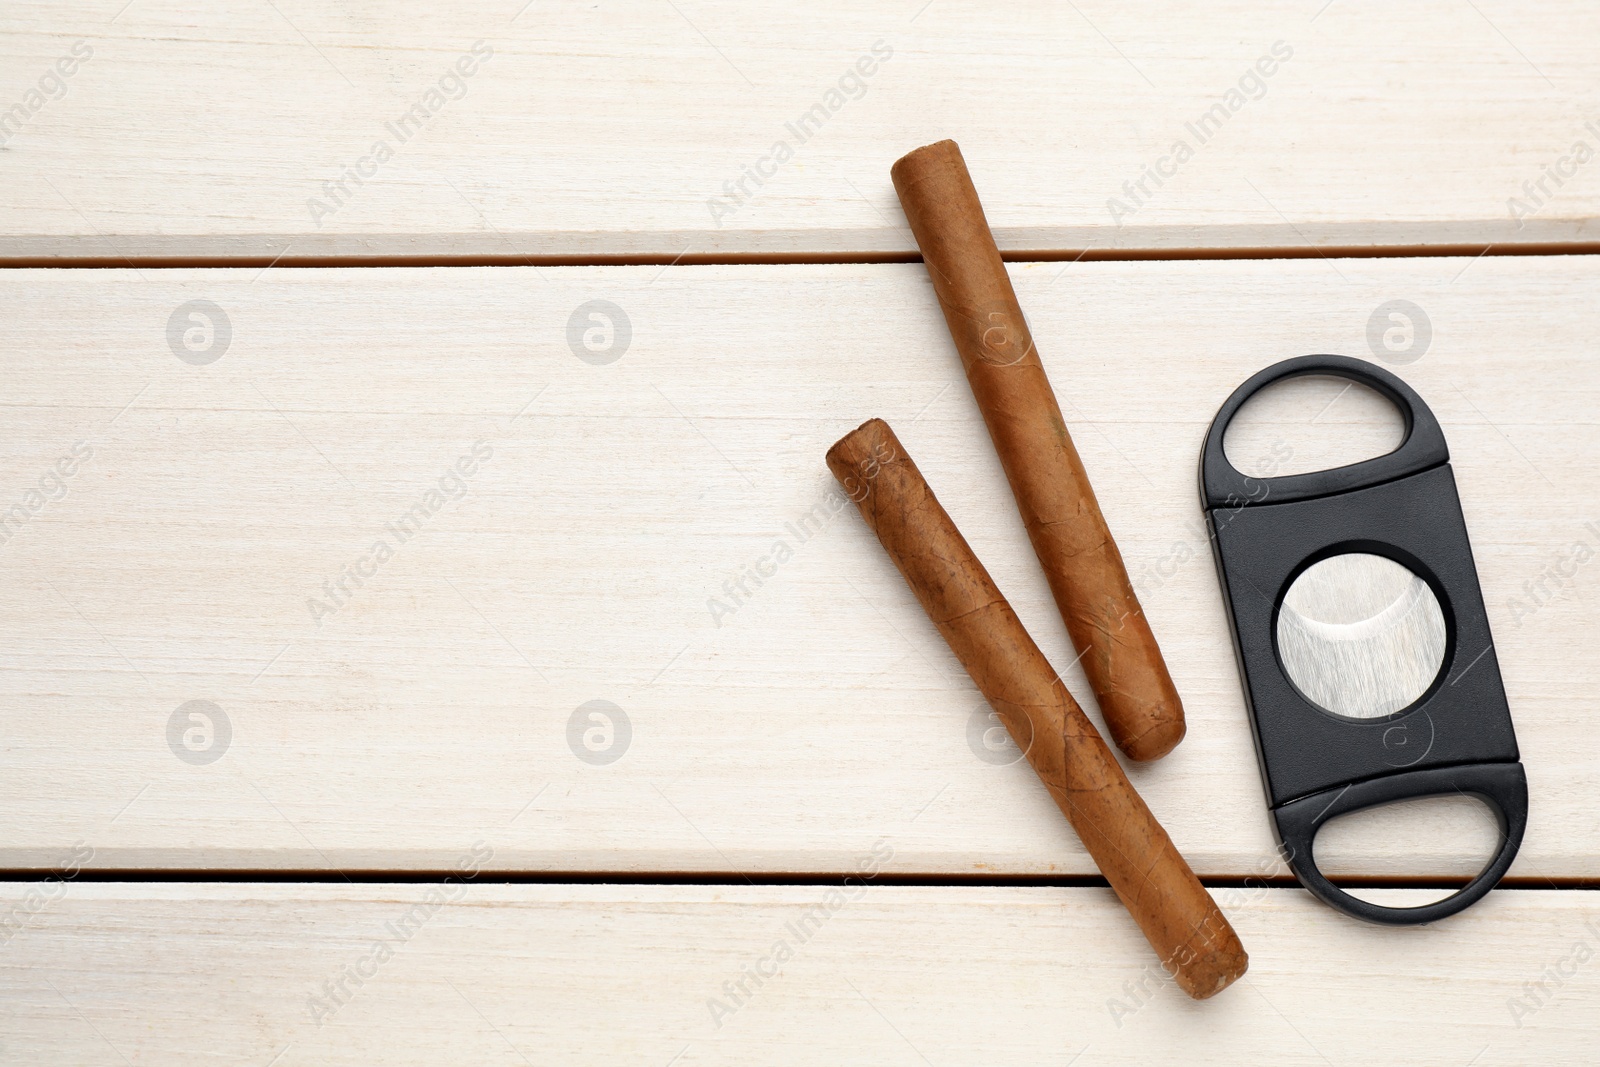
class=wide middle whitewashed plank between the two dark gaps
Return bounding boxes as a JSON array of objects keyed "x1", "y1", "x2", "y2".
[{"x1": 0, "y1": 258, "x2": 1600, "y2": 880}]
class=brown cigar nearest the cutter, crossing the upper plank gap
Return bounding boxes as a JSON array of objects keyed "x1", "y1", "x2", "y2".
[{"x1": 891, "y1": 141, "x2": 1184, "y2": 760}]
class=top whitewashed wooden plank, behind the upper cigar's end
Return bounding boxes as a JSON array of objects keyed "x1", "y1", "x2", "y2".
[{"x1": 0, "y1": 0, "x2": 1600, "y2": 262}]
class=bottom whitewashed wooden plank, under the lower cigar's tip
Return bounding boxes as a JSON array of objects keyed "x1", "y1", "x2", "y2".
[{"x1": 0, "y1": 883, "x2": 1600, "y2": 1067}]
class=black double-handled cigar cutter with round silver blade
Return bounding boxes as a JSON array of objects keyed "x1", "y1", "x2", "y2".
[{"x1": 1200, "y1": 355, "x2": 1528, "y2": 925}]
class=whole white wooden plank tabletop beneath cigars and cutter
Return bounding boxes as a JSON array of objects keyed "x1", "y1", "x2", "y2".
[{"x1": 0, "y1": 0, "x2": 1600, "y2": 1067}]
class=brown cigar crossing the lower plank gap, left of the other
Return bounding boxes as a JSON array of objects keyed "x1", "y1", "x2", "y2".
[{"x1": 827, "y1": 419, "x2": 1248, "y2": 1000}]
